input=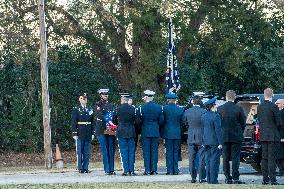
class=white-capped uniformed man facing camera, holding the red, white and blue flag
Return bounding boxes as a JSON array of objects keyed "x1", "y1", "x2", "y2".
[{"x1": 94, "y1": 89, "x2": 115, "y2": 175}]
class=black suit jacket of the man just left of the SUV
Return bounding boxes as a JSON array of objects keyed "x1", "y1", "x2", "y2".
[{"x1": 218, "y1": 102, "x2": 246, "y2": 143}]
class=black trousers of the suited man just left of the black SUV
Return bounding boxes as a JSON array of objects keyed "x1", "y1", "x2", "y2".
[{"x1": 223, "y1": 142, "x2": 241, "y2": 180}]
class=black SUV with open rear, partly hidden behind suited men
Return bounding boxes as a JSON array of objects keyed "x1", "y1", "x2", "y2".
[{"x1": 235, "y1": 94, "x2": 284, "y2": 171}]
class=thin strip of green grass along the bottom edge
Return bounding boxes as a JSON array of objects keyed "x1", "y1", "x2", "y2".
[{"x1": 1, "y1": 183, "x2": 284, "y2": 189}]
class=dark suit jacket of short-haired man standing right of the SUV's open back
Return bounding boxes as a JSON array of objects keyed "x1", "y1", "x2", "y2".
[{"x1": 257, "y1": 100, "x2": 281, "y2": 142}]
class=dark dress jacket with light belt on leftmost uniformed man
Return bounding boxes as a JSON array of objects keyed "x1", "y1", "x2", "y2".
[{"x1": 71, "y1": 106, "x2": 94, "y2": 140}]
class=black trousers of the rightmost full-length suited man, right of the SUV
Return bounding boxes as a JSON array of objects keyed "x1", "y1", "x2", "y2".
[{"x1": 261, "y1": 141, "x2": 280, "y2": 182}]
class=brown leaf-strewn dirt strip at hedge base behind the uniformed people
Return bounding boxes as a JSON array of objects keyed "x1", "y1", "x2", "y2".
[{"x1": 0, "y1": 140, "x2": 187, "y2": 167}]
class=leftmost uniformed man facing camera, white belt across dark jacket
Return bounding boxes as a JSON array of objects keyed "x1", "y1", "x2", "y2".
[{"x1": 71, "y1": 93, "x2": 94, "y2": 173}]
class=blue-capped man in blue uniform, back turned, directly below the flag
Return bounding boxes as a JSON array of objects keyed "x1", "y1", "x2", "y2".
[{"x1": 161, "y1": 93, "x2": 184, "y2": 175}]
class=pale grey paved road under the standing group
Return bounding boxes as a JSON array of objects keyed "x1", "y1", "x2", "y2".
[{"x1": 0, "y1": 164, "x2": 284, "y2": 184}]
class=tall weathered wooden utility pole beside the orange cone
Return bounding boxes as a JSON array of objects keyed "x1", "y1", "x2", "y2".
[{"x1": 38, "y1": 0, "x2": 52, "y2": 169}]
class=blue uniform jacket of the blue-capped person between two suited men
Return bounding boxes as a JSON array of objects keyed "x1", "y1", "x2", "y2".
[{"x1": 201, "y1": 111, "x2": 223, "y2": 145}]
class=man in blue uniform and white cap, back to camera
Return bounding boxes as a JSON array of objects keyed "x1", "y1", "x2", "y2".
[{"x1": 139, "y1": 90, "x2": 164, "y2": 175}]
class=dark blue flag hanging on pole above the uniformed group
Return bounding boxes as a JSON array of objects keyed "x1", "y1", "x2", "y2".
[{"x1": 166, "y1": 18, "x2": 181, "y2": 94}]
